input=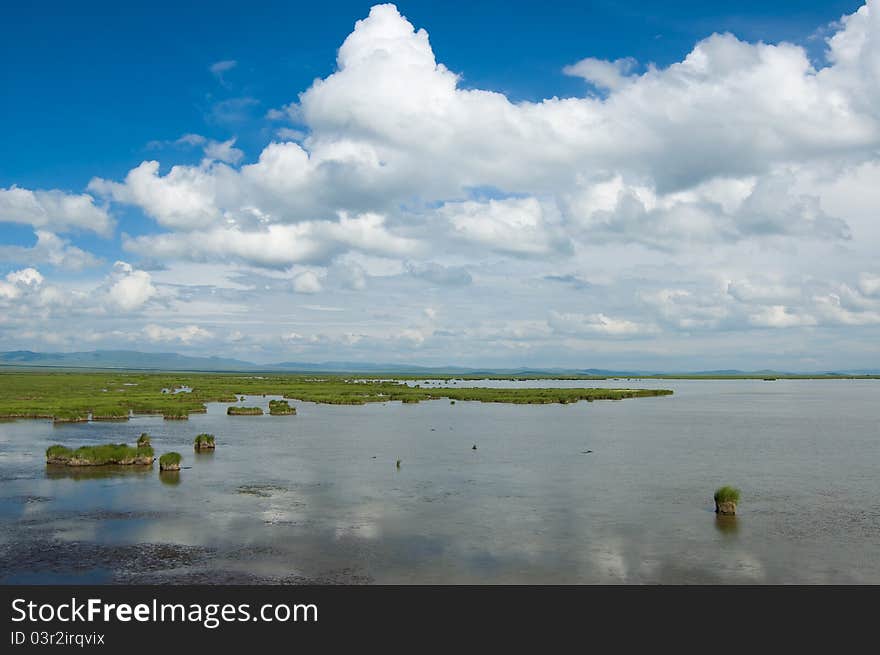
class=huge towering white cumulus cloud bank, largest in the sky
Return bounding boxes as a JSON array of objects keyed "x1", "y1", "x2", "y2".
[{"x1": 82, "y1": 2, "x2": 880, "y2": 276}]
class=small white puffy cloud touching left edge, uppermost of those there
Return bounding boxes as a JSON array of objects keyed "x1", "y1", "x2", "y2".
[{"x1": 0, "y1": 186, "x2": 113, "y2": 236}]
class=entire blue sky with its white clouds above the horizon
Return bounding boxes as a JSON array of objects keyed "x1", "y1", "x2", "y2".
[{"x1": 0, "y1": 2, "x2": 880, "y2": 369}]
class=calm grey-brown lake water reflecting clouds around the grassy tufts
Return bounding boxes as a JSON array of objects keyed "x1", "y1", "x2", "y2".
[{"x1": 0, "y1": 380, "x2": 880, "y2": 584}]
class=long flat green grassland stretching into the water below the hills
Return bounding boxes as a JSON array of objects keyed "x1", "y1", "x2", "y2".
[{"x1": 0, "y1": 371, "x2": 672, "y2": 421}]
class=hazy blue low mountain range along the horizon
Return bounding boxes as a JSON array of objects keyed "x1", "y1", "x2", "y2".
[{"x1": 0, "y1": 350, "x2": 880, "y2": 377}]
